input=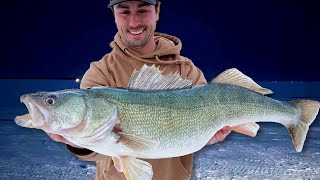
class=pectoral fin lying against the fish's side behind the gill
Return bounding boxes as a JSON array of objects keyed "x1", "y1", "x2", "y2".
[{"x1": 117, "y1": 132, "x2": 159, "y2": 151}]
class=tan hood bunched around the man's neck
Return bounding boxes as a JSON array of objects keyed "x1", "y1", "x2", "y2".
[{"x1": 110, "y1": 32, "x2": 187, "y2": 64}]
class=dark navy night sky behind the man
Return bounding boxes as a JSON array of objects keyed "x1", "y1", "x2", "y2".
[{"x1": 0, "y1": 0, "x2": 320, "y2": 81}]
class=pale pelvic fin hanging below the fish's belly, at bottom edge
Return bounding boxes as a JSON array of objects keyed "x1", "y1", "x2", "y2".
[{"x1": 116, "y1": 157, "x2": 153, "y2": 180}]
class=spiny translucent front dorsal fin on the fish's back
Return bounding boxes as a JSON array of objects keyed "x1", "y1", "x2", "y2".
[{"x1": 127, "y1": 64, "x2": 192, "y2": 90}]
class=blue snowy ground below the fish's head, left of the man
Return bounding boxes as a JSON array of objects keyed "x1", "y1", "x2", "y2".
[{"x1": 0, "y1": 121, "x2": 95, "y2": 180}]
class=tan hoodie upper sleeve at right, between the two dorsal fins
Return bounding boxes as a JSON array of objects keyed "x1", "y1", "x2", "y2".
[{"x1": 181, "y1": 60, "x2": 207, "y2": 85}]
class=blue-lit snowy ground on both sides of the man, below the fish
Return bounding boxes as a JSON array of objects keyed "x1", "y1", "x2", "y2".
[{"x1": 0, "y1": 121, "x2": 320, "y2": 180}]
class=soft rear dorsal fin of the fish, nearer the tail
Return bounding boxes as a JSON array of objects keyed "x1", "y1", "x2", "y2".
[{"x1": 211, "y1": 68, "x2": 273, "y2": 95}]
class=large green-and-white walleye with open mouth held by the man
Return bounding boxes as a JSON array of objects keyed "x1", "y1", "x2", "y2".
[{"x1": 15, "y1": 65, "x2": 320, "y2": 179}]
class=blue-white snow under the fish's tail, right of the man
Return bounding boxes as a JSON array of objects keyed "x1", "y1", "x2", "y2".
[{"x1": 192, "y1": 123, "x2": 320, "y2": 179}]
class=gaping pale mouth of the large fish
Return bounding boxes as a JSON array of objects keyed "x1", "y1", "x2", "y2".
[{"x1": 14, "y1": 94, "x2": 45, "y2": 127}]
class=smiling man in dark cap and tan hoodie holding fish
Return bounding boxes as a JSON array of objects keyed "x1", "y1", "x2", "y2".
[{"x1": 49, "y1": 0, "x2": 231, "y2": 180}]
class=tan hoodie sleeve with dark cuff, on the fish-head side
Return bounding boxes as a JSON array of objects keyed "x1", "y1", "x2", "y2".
[{"x1": 66, "y1": 59, "x2": 111, "y2": 161}]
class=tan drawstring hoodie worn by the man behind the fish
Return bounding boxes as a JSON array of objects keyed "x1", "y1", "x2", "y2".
[{"x1": 67, "y1": 33, "x2": 207, "y2": 180}]
